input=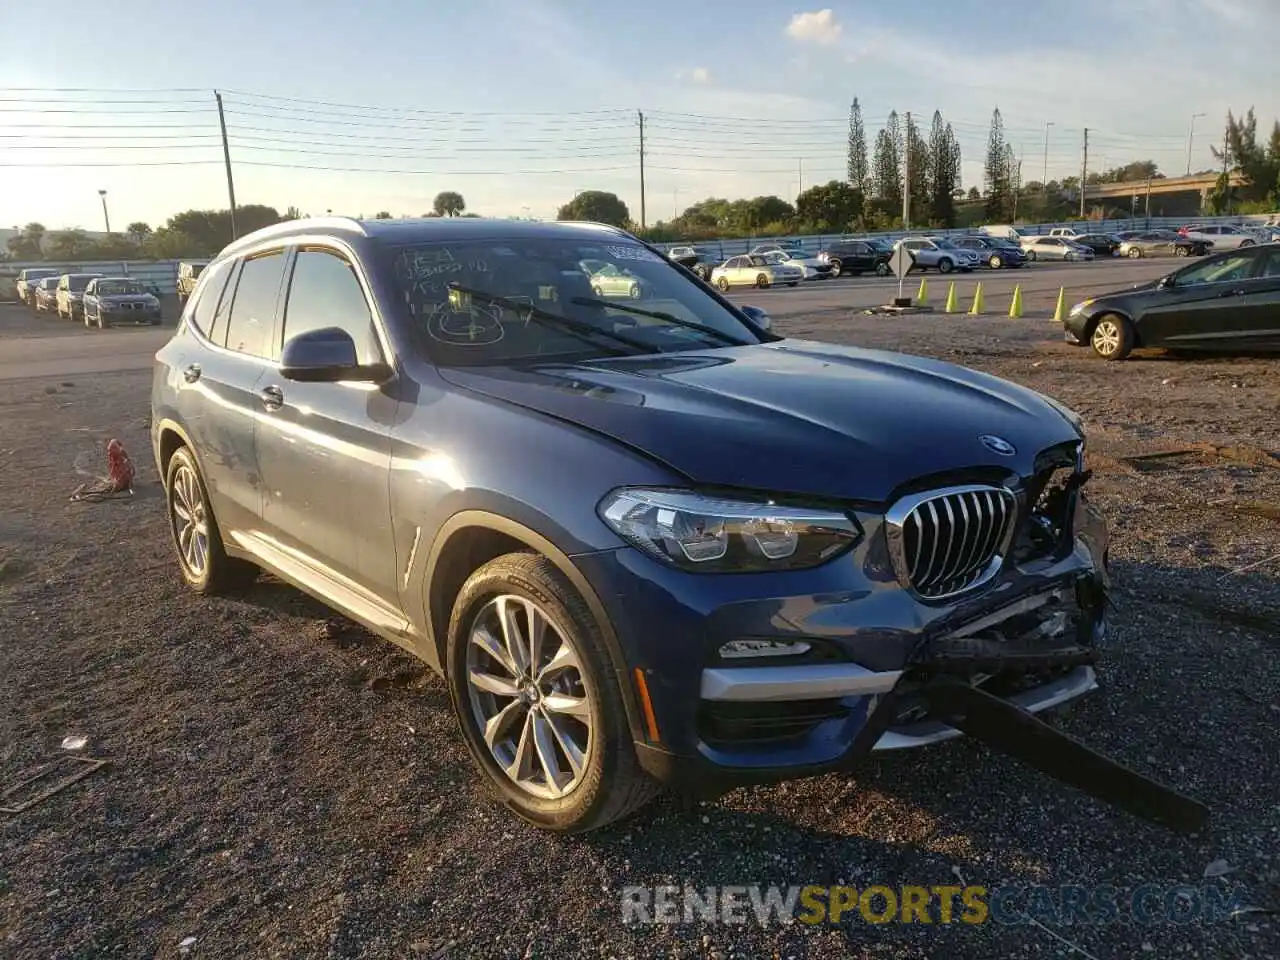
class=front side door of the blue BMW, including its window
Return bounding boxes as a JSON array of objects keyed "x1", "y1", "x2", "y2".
[{"x1": 249, "y1": 246, "x2": 398, "y2": 616}]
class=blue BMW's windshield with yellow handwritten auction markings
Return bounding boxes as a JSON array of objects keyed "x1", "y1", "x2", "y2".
[{"x1": 378, "y1": 238, "x2": 756, "y2": 366}]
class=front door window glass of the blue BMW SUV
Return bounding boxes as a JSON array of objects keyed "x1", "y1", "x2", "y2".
[{"x1": 284, "y1": 248, "x2": 381, "y2": 364}]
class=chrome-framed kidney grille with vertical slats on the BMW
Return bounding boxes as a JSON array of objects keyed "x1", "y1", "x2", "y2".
[{"x1": 886, "y1": 484, "x2": 1018, "y2": 599}]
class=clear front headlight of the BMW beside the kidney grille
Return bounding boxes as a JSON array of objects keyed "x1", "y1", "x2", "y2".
[{"x1": 599, "y1": 488, "x2": 861, "y2": 573}]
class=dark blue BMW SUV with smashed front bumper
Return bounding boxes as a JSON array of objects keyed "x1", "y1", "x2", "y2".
[{"x1": 152, "y1": 218, "x2": 1126, "y2": 832}]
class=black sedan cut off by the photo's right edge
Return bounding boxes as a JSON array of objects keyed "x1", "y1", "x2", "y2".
[{"x1": 1064, "y1": 244, "x2": 1280, "y2": 360}]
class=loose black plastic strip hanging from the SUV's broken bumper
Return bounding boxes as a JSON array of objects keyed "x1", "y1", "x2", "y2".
[{"x1": 920, "y1": 677, "x2": 1208, "y2": 833}]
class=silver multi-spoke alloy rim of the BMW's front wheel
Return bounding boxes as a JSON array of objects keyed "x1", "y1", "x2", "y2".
[{"x1": 466, "y1": 594, "x2": 593, "y2": 800}]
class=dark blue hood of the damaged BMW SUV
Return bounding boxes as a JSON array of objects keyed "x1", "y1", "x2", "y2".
[{"x1": 442, "y1": 339, "x2": 1078, "y2": 503}]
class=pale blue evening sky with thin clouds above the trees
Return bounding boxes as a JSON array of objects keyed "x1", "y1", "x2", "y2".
[{"x1": 0, "y1": 0, "x2": 1280, "y2": 232}]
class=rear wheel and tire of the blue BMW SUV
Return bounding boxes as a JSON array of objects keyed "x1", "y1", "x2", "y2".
[{"x1": 164, "y1": 447, "x2": 257, "y2": 596}]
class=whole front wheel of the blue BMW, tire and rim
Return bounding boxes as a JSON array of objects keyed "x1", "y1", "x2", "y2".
[{"x1": 445, "y1": 553, "x2": 659, "y2": 833}]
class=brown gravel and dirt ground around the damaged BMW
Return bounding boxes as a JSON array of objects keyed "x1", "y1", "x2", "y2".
[{"x1": 0, "y1": 302, "x2": 1280, "y2": 960}]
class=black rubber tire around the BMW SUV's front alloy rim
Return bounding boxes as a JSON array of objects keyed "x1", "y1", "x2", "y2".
[{"x1": 445, "y1": 554, "x2": 632, "y2": 832}]
